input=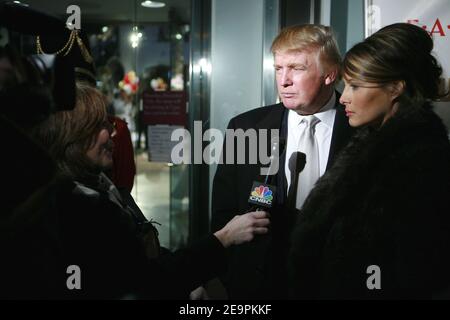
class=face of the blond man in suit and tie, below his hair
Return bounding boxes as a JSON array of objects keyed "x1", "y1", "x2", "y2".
[{"x1": 274, "y1": 51, "x2": 331, "y2": 115}]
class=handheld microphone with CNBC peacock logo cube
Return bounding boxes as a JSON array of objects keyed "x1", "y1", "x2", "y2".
[{"x1": 248, "y1": 137, "x2": 286, "y2": 209}]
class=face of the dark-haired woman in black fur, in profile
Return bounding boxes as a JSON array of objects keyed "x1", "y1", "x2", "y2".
[{"x1": 339, "y1": 77, "x2": 398, "y2": 127}]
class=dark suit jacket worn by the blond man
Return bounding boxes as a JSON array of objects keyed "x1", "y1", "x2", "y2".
[{"x1": 212, "y1": 97, "x2": 352, "y2": 299}]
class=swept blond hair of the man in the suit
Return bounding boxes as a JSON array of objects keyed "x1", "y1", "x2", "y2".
[{"x1": 271, "y1": 24, "x2": 341, "y2": 72}]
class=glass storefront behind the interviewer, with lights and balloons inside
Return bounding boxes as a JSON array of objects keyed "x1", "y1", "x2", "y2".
[{"x1": 22, "y1": 0, "x2": 191, "y2": 249}]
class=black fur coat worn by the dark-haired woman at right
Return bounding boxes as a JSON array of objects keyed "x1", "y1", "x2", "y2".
[{"x1": 289, "y1": 108, "x2": 450, "y2": 299}]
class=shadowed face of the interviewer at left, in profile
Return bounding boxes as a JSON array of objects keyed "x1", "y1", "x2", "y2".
[{"x1": 86, "y1": 121, "x2": 114, "y2": 171}]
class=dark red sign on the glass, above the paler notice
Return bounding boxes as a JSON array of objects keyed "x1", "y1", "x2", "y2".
[{"x1": 142, "y1": 91, "x2": 186, "y2": 126}]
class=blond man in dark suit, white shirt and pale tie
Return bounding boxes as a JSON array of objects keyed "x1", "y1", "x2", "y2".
[{"x1": 212, "y1": 25, "x2": 351, "y2": 299}]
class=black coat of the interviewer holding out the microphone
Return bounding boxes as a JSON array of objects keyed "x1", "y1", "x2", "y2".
[{"x1": 0, "y1": 181, "x2": 226, "y2": 299}]
